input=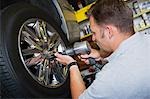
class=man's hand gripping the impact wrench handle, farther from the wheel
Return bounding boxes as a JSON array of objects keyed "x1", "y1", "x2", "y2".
[{"x1": 79, "y1": 49, "x2": 102, "y2": 64}]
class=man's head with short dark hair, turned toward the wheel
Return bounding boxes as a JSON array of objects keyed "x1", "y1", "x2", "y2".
[{"x1": 90, "y1": 0, "x2": 134, "y2": 52}]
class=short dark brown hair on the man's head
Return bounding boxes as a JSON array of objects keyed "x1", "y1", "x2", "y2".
[{"x1": 89, "y1": 0, "x2": 134, "y2": 33}]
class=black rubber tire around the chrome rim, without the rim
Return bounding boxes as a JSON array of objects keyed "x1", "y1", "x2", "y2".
[{"x1": 0, "y1": 3, "x2": 70, "y2": 98}]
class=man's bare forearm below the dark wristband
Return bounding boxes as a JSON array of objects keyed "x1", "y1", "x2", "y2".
[{"x1": 70, "y1": 66, "x2": 86, "y2": 99}]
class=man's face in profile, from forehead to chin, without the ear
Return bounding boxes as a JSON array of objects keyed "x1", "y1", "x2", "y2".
[{"x1": 90, "y1": 16, "x2": 111, "y2": 52}]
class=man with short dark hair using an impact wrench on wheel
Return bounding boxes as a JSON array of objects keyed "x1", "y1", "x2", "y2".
[{"x1": 55, "y1": 0, "x2": 150, "y2": 99}]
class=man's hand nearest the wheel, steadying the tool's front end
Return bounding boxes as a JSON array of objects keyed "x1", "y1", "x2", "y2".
[{"x1": 55, "y1": 53, "x2": 75, "y2": 65}]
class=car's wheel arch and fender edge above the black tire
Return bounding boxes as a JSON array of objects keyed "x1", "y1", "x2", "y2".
[{"x1": 1, "y1": 0, "x2": 80, "y2": 45}]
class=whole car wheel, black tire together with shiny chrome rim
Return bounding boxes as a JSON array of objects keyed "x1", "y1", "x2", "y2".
[{"x1": 0, "y1": 3, "x2": 70, "y2": 98}]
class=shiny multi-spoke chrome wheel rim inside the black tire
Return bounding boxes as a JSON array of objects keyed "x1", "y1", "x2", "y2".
[{"x1": 18, "y1": 19, "x2": 68, "y2": 88}]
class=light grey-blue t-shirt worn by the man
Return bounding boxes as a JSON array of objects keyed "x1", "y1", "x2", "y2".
[{"x1": 79, "y1": 33, "x2": 150, "y2": 99}]
